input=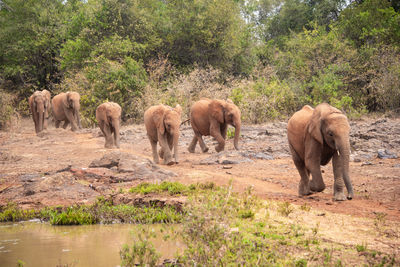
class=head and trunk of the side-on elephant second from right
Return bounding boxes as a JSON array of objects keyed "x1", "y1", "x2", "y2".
[{"x1": 209, "y1": 99, "x2": 242, "y2": 150}]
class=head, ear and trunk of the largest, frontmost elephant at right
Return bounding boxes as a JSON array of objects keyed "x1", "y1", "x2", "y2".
[{"x1": 307, "y1": 103, "x2": 354, "y2": 199}]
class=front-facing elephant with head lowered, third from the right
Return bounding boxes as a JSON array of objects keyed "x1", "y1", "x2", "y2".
[{"x1": 144, "y1": 105, "x2": 182, "y2": 165}]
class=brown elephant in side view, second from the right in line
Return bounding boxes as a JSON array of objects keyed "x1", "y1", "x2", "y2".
[{"x1": 188, "y1": 98, "x2": 241, "y2": 153}]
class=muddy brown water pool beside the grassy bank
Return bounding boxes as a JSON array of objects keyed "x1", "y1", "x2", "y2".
[{"x1": 0, "y1": 221, "x2": 182, "y2": 267}]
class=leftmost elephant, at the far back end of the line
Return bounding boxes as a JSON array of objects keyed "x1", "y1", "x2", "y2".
[{"x1": 28, "y1": 91, "x2": 48, "y2": 134}]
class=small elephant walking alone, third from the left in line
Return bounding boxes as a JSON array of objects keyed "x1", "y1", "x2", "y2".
[{"x1": 96, "y1": 102, "x2": 121, "y2": 148}]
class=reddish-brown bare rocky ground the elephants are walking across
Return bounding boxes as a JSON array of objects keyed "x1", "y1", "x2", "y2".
[{"x1": 0, "y1": 118, "x2": 400, "y2": 258}]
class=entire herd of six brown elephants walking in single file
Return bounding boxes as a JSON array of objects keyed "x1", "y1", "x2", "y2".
[{"x1": 29, "y1": 90, "x2": 354, "y2": 201}]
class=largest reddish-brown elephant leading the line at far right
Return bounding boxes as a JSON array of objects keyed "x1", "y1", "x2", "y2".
[{"x1": 287, "y1": 103, "x2": 354, "y2": 201}]
